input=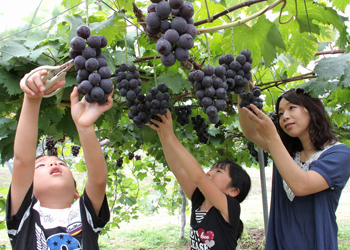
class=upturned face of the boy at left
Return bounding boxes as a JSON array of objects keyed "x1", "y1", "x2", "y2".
[{"x1": 33, "y1": 156, "x2": 75, "y2": 197}]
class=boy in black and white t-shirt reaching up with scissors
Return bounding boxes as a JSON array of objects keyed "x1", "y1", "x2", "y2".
[{"x1": 6, "y1": 71, "x2": 113, "y2": 250}]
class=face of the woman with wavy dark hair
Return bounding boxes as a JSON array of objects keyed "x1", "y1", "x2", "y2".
[{"x1": 278, "y1": 98, "x2": 310, "y2": 141}]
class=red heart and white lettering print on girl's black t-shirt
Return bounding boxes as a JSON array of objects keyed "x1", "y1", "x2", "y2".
[{"x1": 190, "y1": 228, "x2": 215, "y2": 250}]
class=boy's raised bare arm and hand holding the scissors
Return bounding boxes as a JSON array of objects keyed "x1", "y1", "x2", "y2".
[{"x1": 11, "y1": 71, "x2": 65, "y2": 215}]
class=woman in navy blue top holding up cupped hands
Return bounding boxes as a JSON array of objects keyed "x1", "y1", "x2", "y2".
[{"x1": 238, "y1": 89, "x2": 350, "y2": 250}]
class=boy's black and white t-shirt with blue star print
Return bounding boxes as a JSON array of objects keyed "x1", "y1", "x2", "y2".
[{"x1": 6, "y1": 185, "x2": 110, "y2": 250}]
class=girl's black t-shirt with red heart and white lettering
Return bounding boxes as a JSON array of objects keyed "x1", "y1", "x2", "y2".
[{"x1": 190, "y1": 188, "x2": 241, "y2": 250}]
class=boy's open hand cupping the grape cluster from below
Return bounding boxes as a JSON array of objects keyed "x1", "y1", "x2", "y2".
[{"x1": 70, "y1": 87, "x2": 113, "y2": 127}]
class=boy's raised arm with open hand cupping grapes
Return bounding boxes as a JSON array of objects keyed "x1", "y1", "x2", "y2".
[{"x1": 70, "y1": 87, "x2": 113, "y2": 215}]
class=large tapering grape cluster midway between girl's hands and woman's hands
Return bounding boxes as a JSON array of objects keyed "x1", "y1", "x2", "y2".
[{"x1": 188, "y1": 65, "x2": 227, "y2": 124}]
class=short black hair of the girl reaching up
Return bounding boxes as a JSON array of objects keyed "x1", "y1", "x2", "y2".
[{"x1": 213, "y1": 160, "x2": 251, "y2": 203}]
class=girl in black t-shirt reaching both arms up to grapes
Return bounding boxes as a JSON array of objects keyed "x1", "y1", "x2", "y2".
[{"x1": 150, "y1": 111, "x2": 251, "y2": 250}]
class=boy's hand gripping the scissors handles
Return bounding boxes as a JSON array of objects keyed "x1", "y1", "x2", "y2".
[{"x1": 20, "y1": 70, "x2": 65, "y2": 99}]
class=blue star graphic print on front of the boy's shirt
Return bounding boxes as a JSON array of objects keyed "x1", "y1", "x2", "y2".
[{"x1": 35, "y1": 223, "x2": 81, "y2": 250}]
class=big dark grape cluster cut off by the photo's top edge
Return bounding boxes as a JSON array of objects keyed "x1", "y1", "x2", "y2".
[{"x1": 145, "y1": 0, "x2": 197, "y2": 67}]
